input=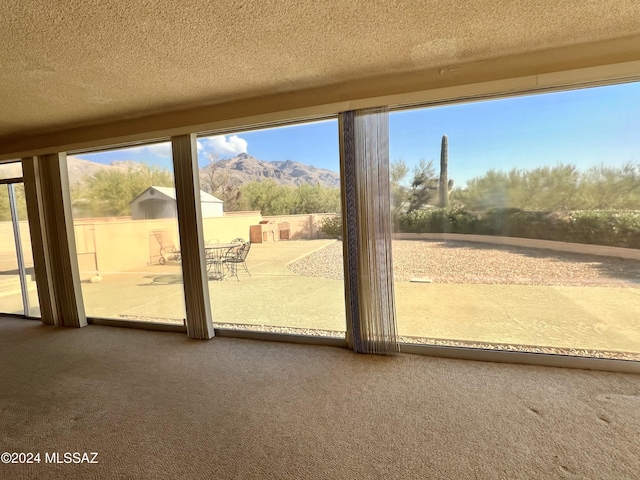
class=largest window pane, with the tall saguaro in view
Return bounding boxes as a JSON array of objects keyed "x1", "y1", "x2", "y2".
[{"x1": 390, "y1": 83, "x2": 640, "y2": 359}]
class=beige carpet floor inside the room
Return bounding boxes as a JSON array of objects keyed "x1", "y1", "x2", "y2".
[{"x1": 0, "y1": 318, "x2": 640, "y2": 479}]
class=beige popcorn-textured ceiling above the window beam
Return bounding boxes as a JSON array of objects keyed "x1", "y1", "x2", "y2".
[{"x1": 0, "y1": 0, "x2": 640, "y2": 146}]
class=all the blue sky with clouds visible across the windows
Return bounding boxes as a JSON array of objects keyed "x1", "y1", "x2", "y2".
[{"x1": 78, "y1": 83, "x2": 640, "y2": 186}]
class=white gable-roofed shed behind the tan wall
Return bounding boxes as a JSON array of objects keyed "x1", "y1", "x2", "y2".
[{"x1": 129, "y1": 187, "x2": 224, "y2": 220}]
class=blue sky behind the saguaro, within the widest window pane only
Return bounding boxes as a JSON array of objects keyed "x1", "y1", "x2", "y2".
[{"x1": 389, "y1": 79, "x2": 640, "y2": 186}]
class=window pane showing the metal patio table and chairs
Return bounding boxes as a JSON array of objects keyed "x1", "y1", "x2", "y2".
[{"x1": 198, "y1": 120, "x2": 346, "y2": 337}]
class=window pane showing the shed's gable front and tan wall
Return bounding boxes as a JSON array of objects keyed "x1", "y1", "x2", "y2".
[{"x1": 67, "y1": 143, "x2": 185, "y2": 324}]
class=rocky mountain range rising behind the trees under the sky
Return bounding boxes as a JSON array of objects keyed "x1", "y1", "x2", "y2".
[{"x1": 67, "y1": 153, "x2": 340, "y2": 188}]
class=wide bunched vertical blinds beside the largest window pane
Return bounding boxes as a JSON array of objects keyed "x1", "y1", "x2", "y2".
[{"x1": 341, "y1": 108, "x2": 398, "y2": 353}]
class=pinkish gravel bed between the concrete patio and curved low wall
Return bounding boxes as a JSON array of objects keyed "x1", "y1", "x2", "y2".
[{"x1": 288, "y1": 240, "x2": 640, "y2": 288}]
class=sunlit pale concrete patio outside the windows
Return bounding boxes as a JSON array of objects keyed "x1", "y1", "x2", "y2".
[{"x1": 0, "y1": 240, "x2": 640, "y2": 358}]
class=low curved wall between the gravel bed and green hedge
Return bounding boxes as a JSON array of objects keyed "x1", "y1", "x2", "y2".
[{"x1": 393, "y1": 233, "x2": 640, "y2": 260}]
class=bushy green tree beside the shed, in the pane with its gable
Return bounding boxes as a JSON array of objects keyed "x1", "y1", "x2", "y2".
[{"x1": 71, "y1": 164, "x2": 174, "y2": 217}]
